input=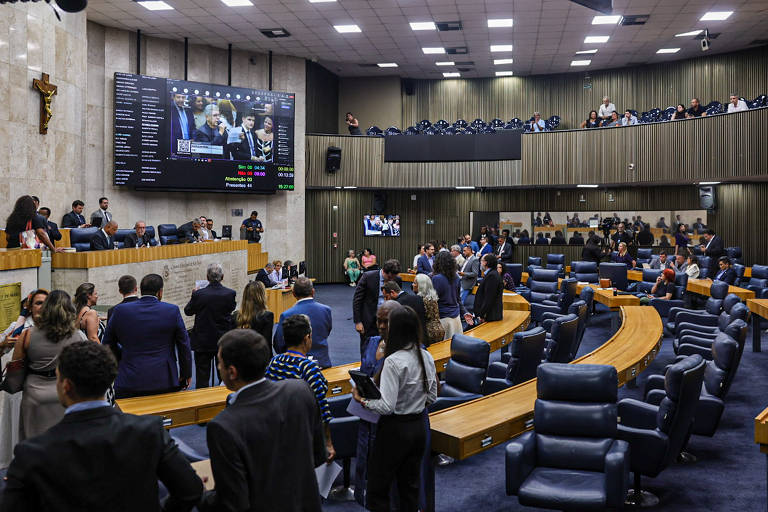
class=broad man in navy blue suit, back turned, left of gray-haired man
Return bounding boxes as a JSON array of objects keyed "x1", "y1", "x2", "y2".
[{"x1": 104, "y1": 274, "x2": 192, "y2": 398}]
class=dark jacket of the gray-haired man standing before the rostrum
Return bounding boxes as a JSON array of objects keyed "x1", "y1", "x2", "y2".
[{"x1": 184, "y1": 283, "x2": 235, "y2": 352}]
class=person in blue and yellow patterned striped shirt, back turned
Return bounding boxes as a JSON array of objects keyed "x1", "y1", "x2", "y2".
[{"x1": 264, "y1": 314, "x2": 336, "y2": 462}]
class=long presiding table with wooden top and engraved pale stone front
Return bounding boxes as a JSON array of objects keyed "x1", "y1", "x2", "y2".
[{"x1": 51, "y1": 240, "x2": 248, "y2": 327}]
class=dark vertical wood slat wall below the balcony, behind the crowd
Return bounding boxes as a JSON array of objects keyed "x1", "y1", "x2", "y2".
[{"x1": 306, "y1": 183, "x2": 768, "y2": 282}]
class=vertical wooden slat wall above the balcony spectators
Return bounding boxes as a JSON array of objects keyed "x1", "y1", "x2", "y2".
[{"x1": 402, "y1": 46, "x2": 768, "y2": 129}]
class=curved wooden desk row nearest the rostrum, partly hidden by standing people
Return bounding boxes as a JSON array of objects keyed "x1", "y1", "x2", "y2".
[{"x1": 117, "y1": 306, "x2": 530, "y2": 428}]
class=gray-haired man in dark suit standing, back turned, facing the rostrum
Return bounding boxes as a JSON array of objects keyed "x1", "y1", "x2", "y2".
[{"x1": 184, "y1": 263, "x2": 236, "y2": 388}]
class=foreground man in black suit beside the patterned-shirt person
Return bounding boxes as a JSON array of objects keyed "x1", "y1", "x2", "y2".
[{"x1": 198, "y1": 329, "x2": 325, "y2": 512}]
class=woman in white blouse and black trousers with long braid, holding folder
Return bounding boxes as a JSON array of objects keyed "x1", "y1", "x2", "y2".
[{"x1": 352, "y1": 306, "x2": 437, "y2": 512}]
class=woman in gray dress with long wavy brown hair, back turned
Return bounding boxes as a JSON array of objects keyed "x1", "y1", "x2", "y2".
[{"x1": 13, "y1": 290, "x2": 86, "y2": 441}]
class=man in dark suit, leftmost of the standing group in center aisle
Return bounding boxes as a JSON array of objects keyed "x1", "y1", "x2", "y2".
[{"x1": 352, "y1": 260, "x2": 403, "y2": 350}]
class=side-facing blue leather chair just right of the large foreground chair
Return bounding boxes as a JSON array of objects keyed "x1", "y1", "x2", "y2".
[{"x1": 616, "y1": 355, "x2": 705, "y2": 506}]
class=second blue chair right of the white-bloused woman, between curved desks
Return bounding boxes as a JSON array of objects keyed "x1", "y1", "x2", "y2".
[{"x1": 485, "y1": 327, "x2": 547, "y2": 388}]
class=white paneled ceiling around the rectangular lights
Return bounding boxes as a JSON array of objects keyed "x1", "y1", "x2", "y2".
[{"x1": 87, "y1": 0, "x2": 768, "y2": 78}]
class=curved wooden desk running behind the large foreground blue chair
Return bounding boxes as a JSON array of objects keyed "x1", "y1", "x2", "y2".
[{"x1": 429, "y1": 306, "x2": 662, "y2": 459}]
